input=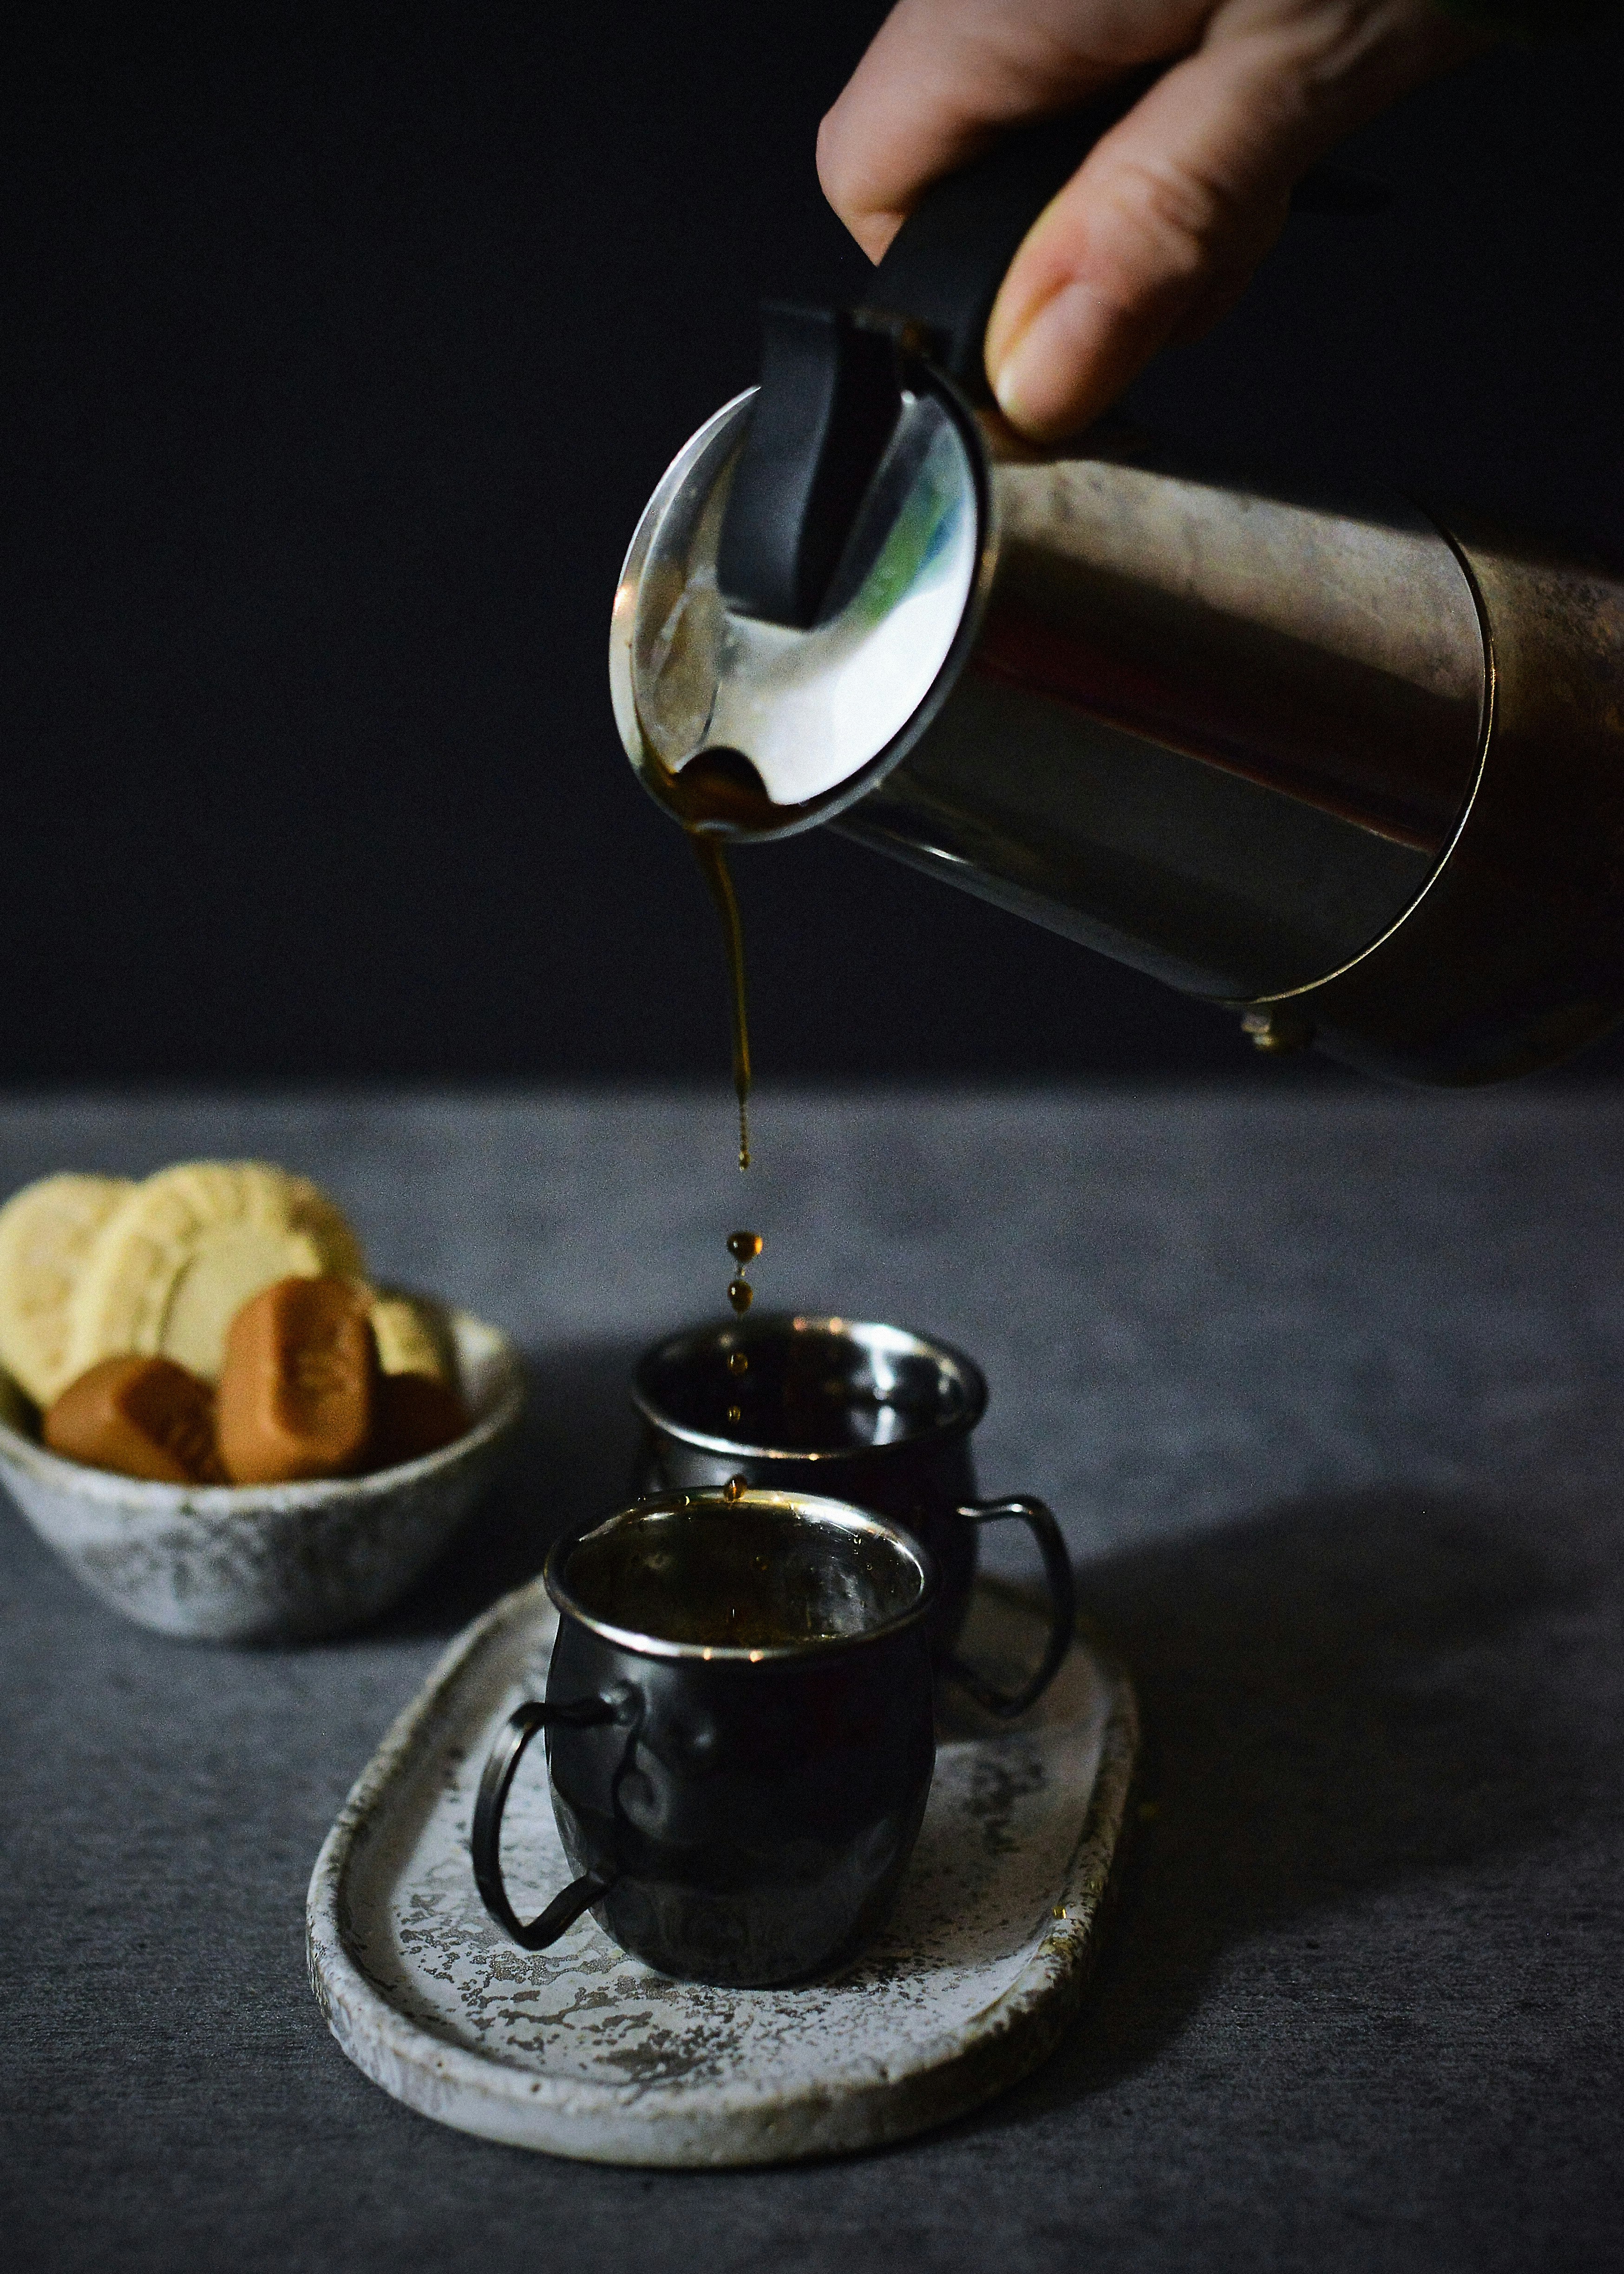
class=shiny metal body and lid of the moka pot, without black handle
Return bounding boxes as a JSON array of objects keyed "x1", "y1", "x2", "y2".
[{"x1": 612, "y1": 361, "x2": 1624, "y2": 1085}]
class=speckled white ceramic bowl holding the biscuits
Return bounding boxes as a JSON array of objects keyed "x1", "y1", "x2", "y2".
[{"x1": 0, "y1": 1310, "x2": 523, "y2": 1642}]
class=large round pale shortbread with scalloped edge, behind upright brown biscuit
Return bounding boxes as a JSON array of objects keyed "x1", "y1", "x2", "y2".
[{"x1": 66, "y1": 1160, "x2": 366, "y2": 1383}]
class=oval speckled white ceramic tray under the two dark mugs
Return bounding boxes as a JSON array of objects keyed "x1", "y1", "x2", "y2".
[{"x1": 307, "y1": 1580, "x2": 1137, "y2": 2165}]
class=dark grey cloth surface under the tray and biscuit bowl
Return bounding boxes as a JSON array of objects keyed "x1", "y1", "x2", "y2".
[{"x1": 0, "y1": 1080, "x2": 1624, "y2": 2274}]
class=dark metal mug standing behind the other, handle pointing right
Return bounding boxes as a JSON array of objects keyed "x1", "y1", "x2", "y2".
[{"x1": 632, "y1": 1312, "x2": 1076, "y2": 1719}]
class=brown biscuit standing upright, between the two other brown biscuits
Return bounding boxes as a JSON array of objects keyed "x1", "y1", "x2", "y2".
[{"x1": 216, "y1": 1278, "x2": 378, "y2": 1485}]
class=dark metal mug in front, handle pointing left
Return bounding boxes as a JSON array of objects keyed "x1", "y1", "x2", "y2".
[{"x1": 473, "y1": 1492, "x2": 937, "y2": 1990}]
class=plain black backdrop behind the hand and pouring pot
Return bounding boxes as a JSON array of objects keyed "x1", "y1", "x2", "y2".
[{"x1": 0, "y1": 0, "x2": 1624, "y2": 1082}]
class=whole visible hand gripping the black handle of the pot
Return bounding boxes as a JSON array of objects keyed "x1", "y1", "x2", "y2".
[{"x1": 817, "y1": 0, "x2": 1485, "y2": 441}]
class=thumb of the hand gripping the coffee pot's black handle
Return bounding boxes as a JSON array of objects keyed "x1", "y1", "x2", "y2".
[{"x1": 987, "y1": 0, "x2": 1476, "y2": 439}]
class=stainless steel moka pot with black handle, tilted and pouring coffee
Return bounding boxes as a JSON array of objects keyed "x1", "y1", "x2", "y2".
[{"x1": 609, "y1": 120, "x2": 1624, "y2": 1082}]
